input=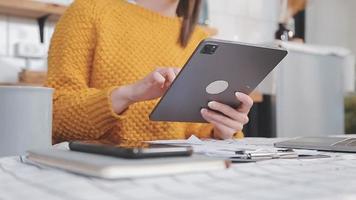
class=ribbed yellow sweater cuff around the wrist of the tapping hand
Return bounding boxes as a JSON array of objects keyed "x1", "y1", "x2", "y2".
[{"x1": 87, "y1": 87, "x2": 125, "y2": 129}]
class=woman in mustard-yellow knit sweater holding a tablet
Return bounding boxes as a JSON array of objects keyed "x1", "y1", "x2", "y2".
[{"x1": 47, "y1": 0, "x2": 252, "y2": 143}]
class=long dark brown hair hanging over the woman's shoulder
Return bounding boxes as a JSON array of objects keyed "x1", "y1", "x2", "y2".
[{"x1": 177, "y1": 0, "x2": 201, "y2": 47}]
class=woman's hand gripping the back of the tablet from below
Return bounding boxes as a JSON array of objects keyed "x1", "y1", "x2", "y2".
[{"x1": 201, "y1": 92, "x2": 253, "y2": 139}]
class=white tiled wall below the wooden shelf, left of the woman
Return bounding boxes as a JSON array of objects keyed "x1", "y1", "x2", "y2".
[{"x1": 0, "y1": 0, "x2": 72, "y2": 82}]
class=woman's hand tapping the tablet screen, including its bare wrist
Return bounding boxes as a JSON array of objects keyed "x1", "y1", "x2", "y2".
[{"x1": 111, "y1": 68, "x2": 180, "y2": 114}]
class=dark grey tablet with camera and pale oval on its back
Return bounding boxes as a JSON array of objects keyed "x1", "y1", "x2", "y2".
[{"x1": 149, "y1": 39, "x2": 287, "y2": 122}]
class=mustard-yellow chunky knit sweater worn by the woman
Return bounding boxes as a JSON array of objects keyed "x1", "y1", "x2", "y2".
[{"x1": 46, "y1": 0, "x2": 243, "y2": 142}]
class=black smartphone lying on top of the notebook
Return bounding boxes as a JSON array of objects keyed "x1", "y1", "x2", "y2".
[{"x1": 69, "y1": 141, "x2": 193, "y2": 159}]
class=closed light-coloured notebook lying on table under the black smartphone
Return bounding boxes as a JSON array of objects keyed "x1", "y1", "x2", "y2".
[{"x1": 26, "y1": 149, "x2": 229, "y2": 179}]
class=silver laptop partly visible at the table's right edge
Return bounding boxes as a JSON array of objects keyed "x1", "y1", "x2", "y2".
[{"x1": 274, "y1": 137, "x2": 356, "y2": 153}]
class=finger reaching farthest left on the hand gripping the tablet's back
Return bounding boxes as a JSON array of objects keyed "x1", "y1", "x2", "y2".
[{"x1": 201, "y1": 108, "x2": 243, "y2": 131}]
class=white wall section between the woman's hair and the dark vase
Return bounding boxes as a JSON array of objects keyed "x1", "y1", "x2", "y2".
[{"x1": 208, "y1": 0, "x2": 280, "y2": 43}]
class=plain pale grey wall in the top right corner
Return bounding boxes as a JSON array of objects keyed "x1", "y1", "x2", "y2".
[{"x1": 306, "y1": 0, "x2": 356, "y2": 59}]
